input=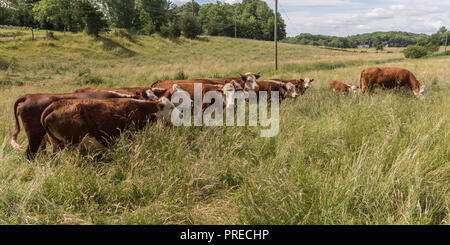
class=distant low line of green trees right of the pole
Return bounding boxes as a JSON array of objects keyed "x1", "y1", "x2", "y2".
[{"x1": 284, "y1": 27, "x2": 447, "y2": 49}]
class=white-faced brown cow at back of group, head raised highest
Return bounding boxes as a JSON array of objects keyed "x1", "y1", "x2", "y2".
[{"x1": 151, "y1": 72, "x2": 260, "y2": 91}]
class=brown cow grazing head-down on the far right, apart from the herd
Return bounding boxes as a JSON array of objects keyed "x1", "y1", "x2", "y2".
[{"x1": 359, "y1": 67, "x2": 427, "y2": 97}]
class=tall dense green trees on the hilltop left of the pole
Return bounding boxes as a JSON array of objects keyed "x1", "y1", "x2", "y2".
[{"x1": 0, "y1": 0, "x2": 286, "y2": 40}]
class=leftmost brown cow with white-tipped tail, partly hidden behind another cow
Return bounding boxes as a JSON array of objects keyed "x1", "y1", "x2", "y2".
[{"x1": 10, "y1": 92, "x2": 136, "y2": 160}]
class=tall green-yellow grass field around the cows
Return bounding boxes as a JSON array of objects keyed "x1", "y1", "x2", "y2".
[{"x1": 0, "y1": 30, "x2": 450, "y2": 224}]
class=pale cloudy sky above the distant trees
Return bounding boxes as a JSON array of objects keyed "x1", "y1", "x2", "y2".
[{"x1": 172, "y1": 0, "x2": 450, "y2": 36}]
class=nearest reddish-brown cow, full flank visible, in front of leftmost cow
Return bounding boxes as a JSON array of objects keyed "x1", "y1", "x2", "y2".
[{"x1": 41, "y1": 97, "x2": 181, "y2": 153}]
